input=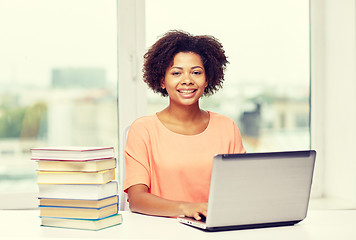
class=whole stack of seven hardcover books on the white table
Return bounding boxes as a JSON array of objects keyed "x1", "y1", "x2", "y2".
[{"x1": 31, "y1": 147, "x2": 122, "y2": 230}]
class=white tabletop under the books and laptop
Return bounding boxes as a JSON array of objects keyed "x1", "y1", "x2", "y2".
[{"x1": 0, "y1": 210, "x2": 356, "y2": 240}]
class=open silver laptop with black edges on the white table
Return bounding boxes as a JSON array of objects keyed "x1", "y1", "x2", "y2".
[{"x1": 178, "y1": 150, "x2": 316, "y2": 231}]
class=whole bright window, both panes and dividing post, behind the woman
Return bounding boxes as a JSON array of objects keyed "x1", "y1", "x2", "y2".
[{"x1": 0, "y1": 0, "x2": 318, "y2": 207}]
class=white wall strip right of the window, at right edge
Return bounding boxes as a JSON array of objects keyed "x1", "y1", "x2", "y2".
[{"x1": 311, "y1": 0, "x2": 356, "y2": 208}]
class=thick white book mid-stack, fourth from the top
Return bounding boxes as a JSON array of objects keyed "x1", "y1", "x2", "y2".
[{"x1": 38, "y1": 181, "x2": 118, "y2": 200}]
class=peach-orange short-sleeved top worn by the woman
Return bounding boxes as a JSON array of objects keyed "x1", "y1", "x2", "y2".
[{"x1": 124, "y1": 112, "x2": 246, "y2": 202}]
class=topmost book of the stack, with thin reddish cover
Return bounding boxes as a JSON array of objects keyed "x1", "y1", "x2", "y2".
[{"x1": 31, "y1": 146, "x2": 114, "y2": 161}]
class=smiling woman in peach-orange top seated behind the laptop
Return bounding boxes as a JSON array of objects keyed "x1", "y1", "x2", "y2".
[{"x1": 124, "y1": 31, "x2": 245, "y2": 220}]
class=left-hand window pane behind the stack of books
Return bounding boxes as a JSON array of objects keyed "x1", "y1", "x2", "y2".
[{"x1": 0, "y1": 0, "x2": 118, "y2": 208}]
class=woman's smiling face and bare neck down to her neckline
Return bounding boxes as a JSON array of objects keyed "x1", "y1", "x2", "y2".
[{"x1": 157, "y1": 52, "x2": 210, "y2": 135}]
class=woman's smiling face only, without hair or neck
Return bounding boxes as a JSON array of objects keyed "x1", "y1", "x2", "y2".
[{"x1": 162, "y1": 52, "x2": 208, "y2": 105}]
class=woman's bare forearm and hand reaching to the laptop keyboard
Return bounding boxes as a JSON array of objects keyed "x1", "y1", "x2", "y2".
[{"x1": 127, "y1": 184, "x2": 208, "y2": 220}]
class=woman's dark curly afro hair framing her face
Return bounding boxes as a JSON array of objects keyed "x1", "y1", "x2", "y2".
[{"x1": 143, "y1": 30, "x2": 229, "y2": 96}]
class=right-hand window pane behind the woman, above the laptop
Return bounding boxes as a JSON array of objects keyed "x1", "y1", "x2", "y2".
[{"x1": 146, "y1": 0, "x2": 310, "y2": 152}]
